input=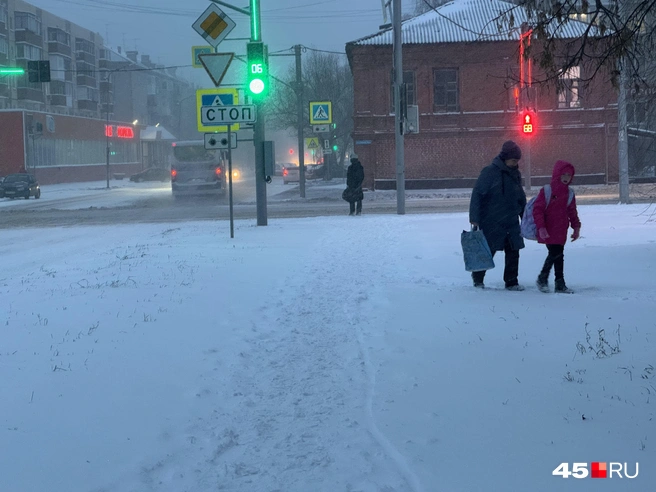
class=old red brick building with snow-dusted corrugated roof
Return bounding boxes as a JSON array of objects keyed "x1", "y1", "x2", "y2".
[{"x1": 346, "y1": 0, "x2": 618, "y2": 189}]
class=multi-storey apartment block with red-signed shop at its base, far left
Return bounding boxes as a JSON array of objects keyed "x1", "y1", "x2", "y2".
[{"x1": 0, "y1": 0, "x2": 195, "y2": 183}]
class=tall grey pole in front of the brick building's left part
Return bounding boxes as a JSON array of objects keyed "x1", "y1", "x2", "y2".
[{"x1": 392, "y1": 0, "x2": 405, "y2": 215}]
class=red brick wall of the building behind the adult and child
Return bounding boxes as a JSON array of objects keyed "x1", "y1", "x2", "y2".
[{"x1": 349, "y1": 42, "x2": 618, "y2": 188}]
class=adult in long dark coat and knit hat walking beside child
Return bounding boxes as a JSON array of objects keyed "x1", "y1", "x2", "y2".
[{"x1": 469, "y1": 140, "x2": 526, "y2": 290}]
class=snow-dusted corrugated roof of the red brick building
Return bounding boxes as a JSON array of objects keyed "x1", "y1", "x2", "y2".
[{"x1": 349, "y1": 0, "x2": 594, "y2": 46}]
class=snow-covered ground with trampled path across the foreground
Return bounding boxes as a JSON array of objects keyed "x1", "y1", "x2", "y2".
[{"x1": 0, "y1": 205, "x2": 656, "y2": 492}]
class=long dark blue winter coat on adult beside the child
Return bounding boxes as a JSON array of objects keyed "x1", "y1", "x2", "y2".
[{"x1": 469, "y1": 156, "x2": 526, "y2": 251}]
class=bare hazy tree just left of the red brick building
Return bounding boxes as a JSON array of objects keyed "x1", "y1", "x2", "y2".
[{"x1": 268, "y1": 49, "x2": 353, "y2": 169}]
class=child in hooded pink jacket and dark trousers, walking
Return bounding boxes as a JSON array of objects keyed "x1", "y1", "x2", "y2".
[{"x1": 533, "y1": 161, "x2": 581, "y2": 294}]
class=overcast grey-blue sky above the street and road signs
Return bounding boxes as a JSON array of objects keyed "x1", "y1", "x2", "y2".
[{"x1": 28, "y1": 0, "x2": 400, "y2": 84}]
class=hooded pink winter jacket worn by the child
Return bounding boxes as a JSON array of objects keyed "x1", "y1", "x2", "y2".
[{"x1": 533, "y1": 161, "x2": 581, "y2": 245}]
